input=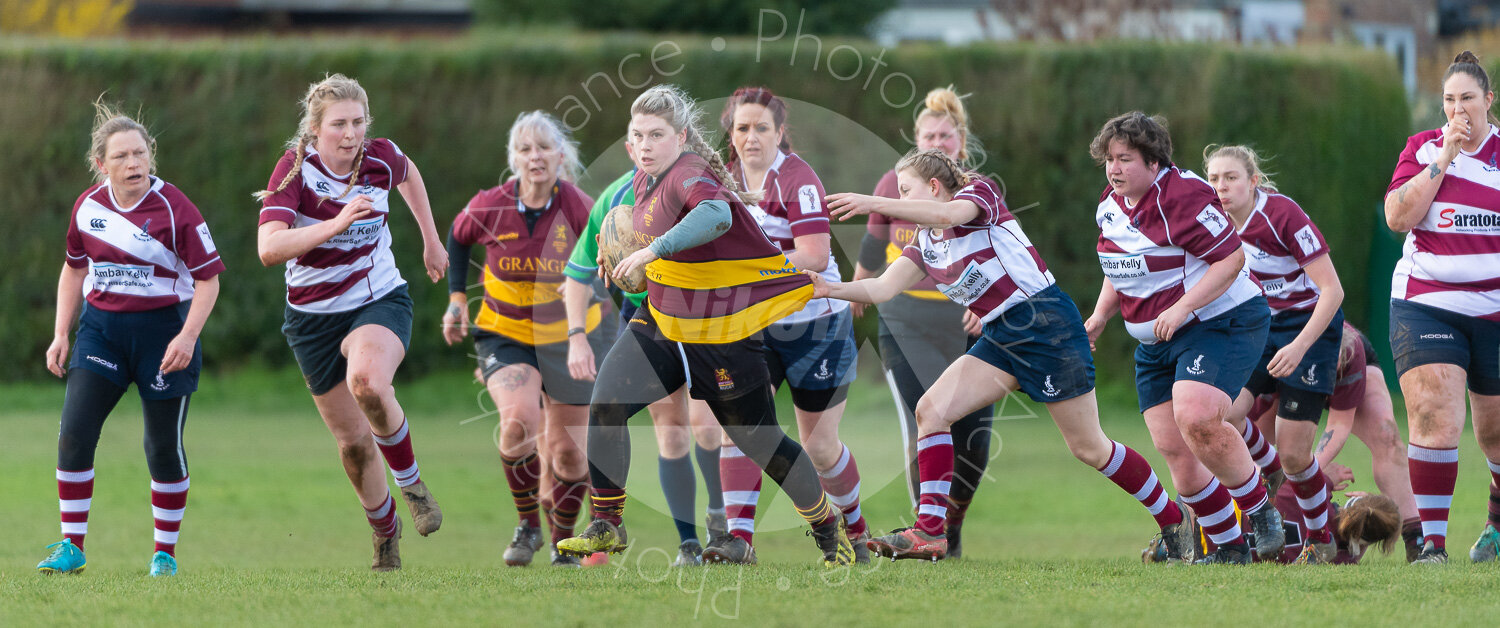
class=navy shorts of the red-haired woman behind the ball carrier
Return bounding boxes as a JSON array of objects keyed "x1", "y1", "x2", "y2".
[{"x1": 762, "y1": 309, "x2": 858, "y2": 391}]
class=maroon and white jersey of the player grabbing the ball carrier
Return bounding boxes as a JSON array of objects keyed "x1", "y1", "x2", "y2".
[{"x1": 902, "y1": 180, "x2": 1058, "y2": 322}]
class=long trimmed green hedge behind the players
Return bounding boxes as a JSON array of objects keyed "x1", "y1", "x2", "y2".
[{"x1": 0, "y1": 39, "x2": 1409, "y2": 379}]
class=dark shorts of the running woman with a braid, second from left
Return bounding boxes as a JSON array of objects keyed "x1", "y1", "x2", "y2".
[{"x1": 282, "y1": 283, "x2": 411, "y2": 396}]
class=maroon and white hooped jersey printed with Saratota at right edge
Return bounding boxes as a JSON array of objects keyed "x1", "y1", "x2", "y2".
[{"x1": 1386, "y1": 124, "x2": 1500, "y2": 321}]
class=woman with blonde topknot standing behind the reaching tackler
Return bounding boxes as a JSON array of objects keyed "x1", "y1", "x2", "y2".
[{"x1": 854, "y1": 87, "x2": 999, "y2": 558}]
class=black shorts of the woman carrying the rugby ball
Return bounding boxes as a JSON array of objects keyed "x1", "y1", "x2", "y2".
[{"x1": 593, "y1": 307, "x2": 771, "y2": 403}]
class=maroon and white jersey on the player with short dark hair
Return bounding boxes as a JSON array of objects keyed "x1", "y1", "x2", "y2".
[{"x1": 1094, "y1": 163, "x2": 1260, "y2": 345}]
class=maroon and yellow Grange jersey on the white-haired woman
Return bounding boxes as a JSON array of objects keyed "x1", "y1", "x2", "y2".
[{"x1": 453, "y1": 180, "x2": 602, "y2": 345}]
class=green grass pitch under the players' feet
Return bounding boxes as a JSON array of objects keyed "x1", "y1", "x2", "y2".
[{"x1": 0, "y1": 364, "x2": 1500, "y2": 627}]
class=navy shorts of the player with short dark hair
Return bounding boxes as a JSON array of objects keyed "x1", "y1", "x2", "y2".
[{"x1": 1136, "y1": 297, "x2": 1271, "y2": 412}]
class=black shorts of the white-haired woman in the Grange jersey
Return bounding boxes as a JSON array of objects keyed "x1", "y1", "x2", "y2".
[{"x1": 474, "y1": 312, "x2": 617, "y2": 406}]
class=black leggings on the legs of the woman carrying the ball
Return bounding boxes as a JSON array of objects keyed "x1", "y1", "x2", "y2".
[{"x1": 588, "y1": 331, "x2": 824, "y2": 510}]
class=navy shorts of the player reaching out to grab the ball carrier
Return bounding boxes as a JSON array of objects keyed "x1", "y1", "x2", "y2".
[{"x1": 969, "y1": 285, "x2": 1094, "y2": 403}]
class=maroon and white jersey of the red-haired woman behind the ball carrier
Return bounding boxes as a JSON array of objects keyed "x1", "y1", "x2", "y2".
[{"x1": 735, "y1": 151, "x2": 849, "y2": 325}]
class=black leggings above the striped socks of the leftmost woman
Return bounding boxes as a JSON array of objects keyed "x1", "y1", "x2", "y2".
[{"x1": 57, "y1": 369, "x2": 192, "y2": 483}]
